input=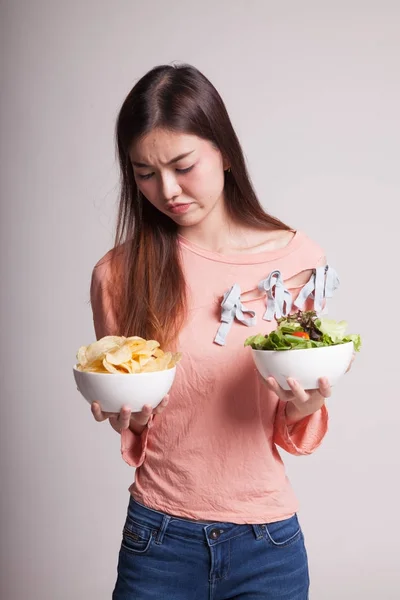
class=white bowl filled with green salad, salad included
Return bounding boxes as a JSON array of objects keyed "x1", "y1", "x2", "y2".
[{"x1": 245, "y1": 311, "x2": 361, "y2": 390}]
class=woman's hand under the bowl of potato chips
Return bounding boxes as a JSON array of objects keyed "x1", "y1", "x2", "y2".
[{"x1": 91, "y1": 395, "x2": 169, "y2": 435}]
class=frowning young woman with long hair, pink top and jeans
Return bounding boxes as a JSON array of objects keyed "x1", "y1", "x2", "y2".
[{"x1": 91, "y1": 65, "x2": 340, "y2": 600}]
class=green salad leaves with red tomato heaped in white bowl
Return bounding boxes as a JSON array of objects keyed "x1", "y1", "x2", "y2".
[{"x1": 244, "y1": 310, "x2": 361, "y2": 352}]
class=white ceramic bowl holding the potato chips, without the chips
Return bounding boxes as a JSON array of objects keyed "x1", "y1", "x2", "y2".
[{"x1": 73, "y1": 365, "x2": 176, "y2": 412}]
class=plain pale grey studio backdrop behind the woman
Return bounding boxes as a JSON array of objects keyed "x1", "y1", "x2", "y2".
[{"x1": 0, "y1": 0, "x2": 400, "y2": 600}]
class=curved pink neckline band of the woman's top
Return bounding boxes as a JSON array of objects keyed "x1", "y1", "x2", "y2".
[{"x1": 178, "y1": 230, "x2": 304, "y2": 265}]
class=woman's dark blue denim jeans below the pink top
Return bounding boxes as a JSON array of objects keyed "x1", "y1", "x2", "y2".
[{"x1": 112, "y1": 498, "x2": 309, "y2": 600}]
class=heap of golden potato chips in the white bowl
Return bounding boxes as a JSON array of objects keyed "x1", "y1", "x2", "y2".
[{"x1": 76, "y1": 335, "x2": 182, "y2": 374}]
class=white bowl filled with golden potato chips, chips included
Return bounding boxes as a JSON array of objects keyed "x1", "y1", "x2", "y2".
[{"x1": 73, "y1": 336, "x2": 182, "y2": 412}]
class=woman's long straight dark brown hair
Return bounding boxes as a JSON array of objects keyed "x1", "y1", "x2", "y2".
[{"x1": 112, "y1": 65, "x2": 290, "y2": 346}]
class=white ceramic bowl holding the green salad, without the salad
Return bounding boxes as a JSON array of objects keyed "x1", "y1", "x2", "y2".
[{"x1": 252, "y1": 342, "x2": 354, "y2": 390}]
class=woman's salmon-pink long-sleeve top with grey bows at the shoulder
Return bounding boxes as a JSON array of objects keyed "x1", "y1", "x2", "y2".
[{"x1": 91, "y1": 231, "x2": 329, "y2": 524}]
